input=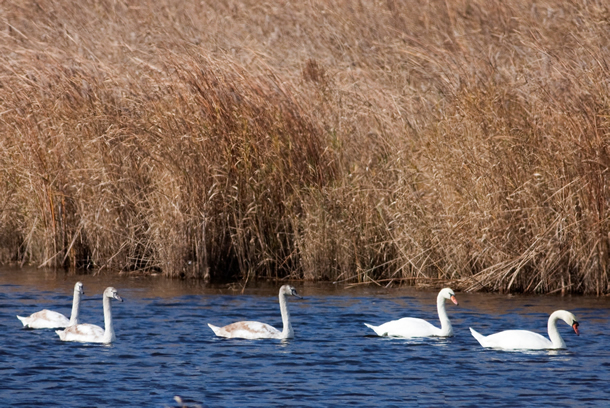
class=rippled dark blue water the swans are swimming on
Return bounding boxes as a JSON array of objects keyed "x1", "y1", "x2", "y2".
[{"x1": 0, "y1": 269, "x2": 610, "y2": 407}]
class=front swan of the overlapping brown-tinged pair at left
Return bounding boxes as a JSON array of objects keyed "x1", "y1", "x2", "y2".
[{"x1": 55, "y1": 287, "x2": 123, "y2": 344}]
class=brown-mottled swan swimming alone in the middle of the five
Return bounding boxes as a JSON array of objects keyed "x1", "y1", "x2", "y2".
[{"x1": 208, "y1": 285, "x2": 302, "y2": 340}]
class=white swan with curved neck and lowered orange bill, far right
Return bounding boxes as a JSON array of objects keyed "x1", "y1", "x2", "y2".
[{"x1": 470, "y1": 310, "x2": 579, "y2": 350}]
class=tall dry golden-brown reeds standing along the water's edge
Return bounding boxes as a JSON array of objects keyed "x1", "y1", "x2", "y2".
[{"x1": 0, "y1": 0, "x2": 610, "y2": 294}]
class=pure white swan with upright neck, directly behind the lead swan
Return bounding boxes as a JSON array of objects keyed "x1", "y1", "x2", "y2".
[{"x1": 364, "y1": 288, "x2": 458, "y2": 338}]
